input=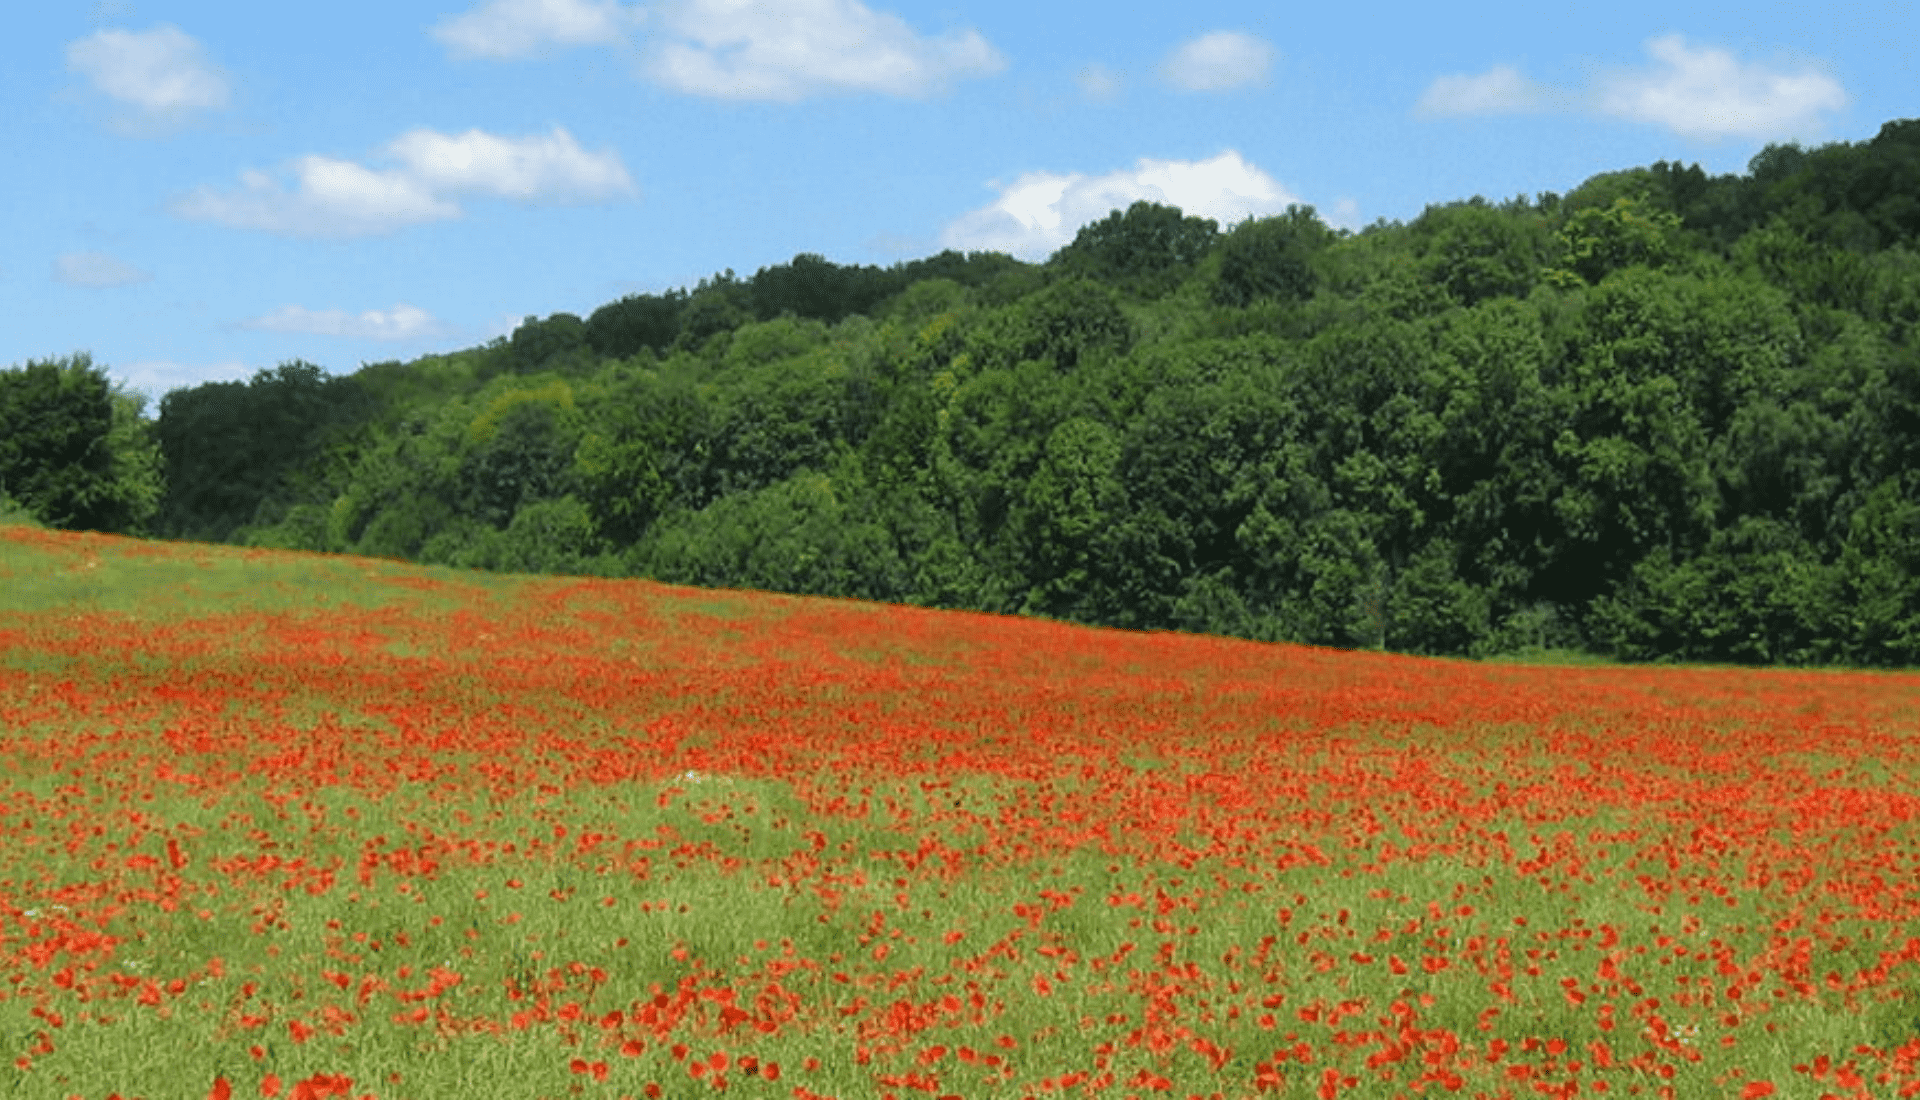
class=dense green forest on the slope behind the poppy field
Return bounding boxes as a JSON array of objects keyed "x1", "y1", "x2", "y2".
[{"x1": 0, "y1": 119, "x2": 1920, "y2": 666}]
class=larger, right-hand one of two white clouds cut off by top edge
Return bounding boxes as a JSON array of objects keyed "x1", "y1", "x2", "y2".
[{"x1": 647, "y1": 0, "x2": 1006, "y2": 102}]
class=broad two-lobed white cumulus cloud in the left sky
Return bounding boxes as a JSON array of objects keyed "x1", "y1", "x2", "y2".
[{"x1": 171, "y1": 127, "x2": 634, "y2": 238}]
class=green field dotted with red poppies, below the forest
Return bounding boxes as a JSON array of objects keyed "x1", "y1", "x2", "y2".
[{"x1": 0, "y1": 528, "x2": 1920, "y2": 1100}]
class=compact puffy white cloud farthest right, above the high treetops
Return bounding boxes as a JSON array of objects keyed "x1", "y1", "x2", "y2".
[{"x1": 1596, "y1": 35, "x2": 1847, "y2": 138}]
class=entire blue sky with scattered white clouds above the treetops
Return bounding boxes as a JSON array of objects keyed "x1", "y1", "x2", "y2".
[{"x1": 0, "y1": 0, "x2": 1920, "y2": 399}]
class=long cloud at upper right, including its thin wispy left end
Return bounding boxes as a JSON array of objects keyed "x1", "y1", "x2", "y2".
[{"x1": 1413, "y1": 35, "x2": 1847, "y2": 140}]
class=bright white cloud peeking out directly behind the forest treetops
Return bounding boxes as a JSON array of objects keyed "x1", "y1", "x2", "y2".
[{"x1": 941, "y1": 150, "x2": 1300, "y2": 259}]
